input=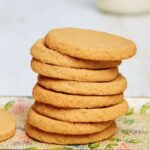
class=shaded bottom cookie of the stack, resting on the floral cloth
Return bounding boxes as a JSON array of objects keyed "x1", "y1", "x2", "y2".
[{"x1": 25, "y1": 122, "x2": 117, "y2": 144}]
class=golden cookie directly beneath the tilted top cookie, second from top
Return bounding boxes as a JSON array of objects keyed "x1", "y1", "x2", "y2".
[{"x1": 31, "y1": 39, "x2": 121, "y2": 69}]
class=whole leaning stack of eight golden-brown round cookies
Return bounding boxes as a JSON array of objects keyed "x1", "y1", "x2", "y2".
[{"x1": 26, "y1": 28, "x2": 136, "y2": 144}]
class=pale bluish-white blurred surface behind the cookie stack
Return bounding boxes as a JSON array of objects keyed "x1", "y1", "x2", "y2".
[{"x1": 0, "y1": 0, "x2": 150, "y2": 97}]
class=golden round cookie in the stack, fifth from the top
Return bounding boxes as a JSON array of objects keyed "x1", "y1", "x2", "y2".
[{"x1": 32, "y1": 84, "x2": 123, "y2": 108}]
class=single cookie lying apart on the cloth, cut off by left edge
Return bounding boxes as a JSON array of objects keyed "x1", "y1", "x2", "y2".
[{"x1": 0, "y1": 109, "x2": 16, "y2": 142}]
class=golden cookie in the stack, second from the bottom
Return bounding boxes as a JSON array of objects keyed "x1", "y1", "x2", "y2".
[{"x1": 27, "y1": 108, "x2": 112, "y2": 135}]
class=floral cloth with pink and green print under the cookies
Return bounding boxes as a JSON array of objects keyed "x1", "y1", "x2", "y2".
[{"x1": 0, "y1": 97, "x2": 150, "y2": 150}]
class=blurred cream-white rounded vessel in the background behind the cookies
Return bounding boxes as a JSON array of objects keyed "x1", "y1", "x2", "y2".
[{"x1": 97, "y1": 0, "x2": 150, "y2": 14}]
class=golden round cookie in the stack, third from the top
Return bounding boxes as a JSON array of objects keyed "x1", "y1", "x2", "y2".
[{"x1": 31, "y1": 59, "x2": 118, "y2": 82}]
